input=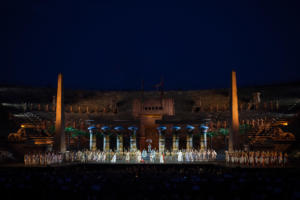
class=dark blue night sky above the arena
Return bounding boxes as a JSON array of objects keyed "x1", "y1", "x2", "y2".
[{"x1": 0, "y1": 0, "x2": 300, "y2": 90}]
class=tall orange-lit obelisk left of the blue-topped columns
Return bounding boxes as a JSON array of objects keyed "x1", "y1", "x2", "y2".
[{"x1": 54, "y1": 73, "x2": 66, "y2": 152}]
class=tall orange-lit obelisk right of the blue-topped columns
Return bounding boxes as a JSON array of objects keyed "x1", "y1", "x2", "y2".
[{"x1": 228, "y1": 71, "x2": 239, "y2": 152}]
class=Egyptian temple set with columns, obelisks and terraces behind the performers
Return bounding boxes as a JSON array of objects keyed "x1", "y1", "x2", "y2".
[{"x1": 1, "y1": 71, "x2": 295, "y2": 152}]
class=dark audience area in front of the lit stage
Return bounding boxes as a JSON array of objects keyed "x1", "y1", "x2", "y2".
[{"x1": 0, "y1": 164, "x2": 300, "y2": 200}]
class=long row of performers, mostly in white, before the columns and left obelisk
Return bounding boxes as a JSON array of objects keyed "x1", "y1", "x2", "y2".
[{"x1": 24, "y1": 150, "x2": 217, "y2": 166}]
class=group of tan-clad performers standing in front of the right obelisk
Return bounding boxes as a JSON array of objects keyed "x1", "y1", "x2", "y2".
[{"x1": 225, "y1": 150, "x2": 288, "y2": 167}]
